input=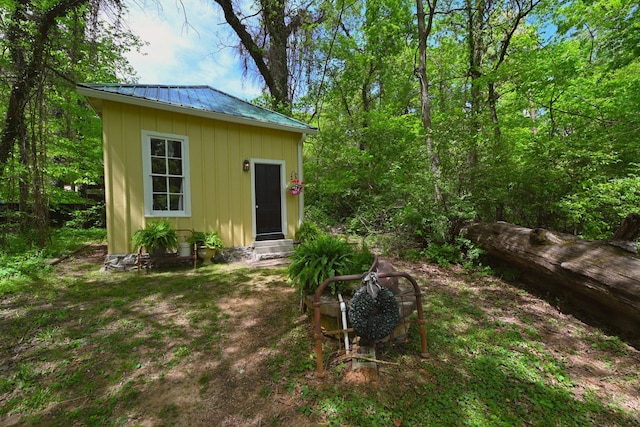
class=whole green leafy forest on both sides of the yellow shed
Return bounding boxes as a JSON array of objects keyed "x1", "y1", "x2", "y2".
[{"x1": 0, "y1": 0, "x2": 640, "y2": 254}]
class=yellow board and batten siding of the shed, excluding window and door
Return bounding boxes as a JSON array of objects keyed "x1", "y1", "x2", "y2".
[{"x1": 102, "y1": 100, "x2": 300, "y2": 254}]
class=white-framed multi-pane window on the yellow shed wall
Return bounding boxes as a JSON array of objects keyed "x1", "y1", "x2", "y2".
[{"x1": 142, "y1": 131, "x2": 191, "y2": 217}]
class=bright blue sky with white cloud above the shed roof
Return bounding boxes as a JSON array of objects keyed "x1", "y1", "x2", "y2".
[{"x1": 126, "y1": 0, "x2": 262, "y2": 100}]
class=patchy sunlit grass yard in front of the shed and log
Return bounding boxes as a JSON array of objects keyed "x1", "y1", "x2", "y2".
[{"x1": 0, "y1": 242, "x2": 640, "y2": 426}]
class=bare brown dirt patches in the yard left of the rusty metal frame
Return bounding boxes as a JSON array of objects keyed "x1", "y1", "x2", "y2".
[{"x1": 51, "y1": 245, "x2": 316, "y2": 427}]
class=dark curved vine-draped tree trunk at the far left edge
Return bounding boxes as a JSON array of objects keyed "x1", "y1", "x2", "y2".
[{"x1": 0, "y1": 0, "x2": 90, "y2": 241}]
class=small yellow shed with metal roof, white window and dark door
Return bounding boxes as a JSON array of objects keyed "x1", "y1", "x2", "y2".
[{"x1": 77, "y1": 84, "x2": 317, "y2": 260}]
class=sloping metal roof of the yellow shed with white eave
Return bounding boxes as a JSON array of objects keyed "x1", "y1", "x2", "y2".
[{"x1": 77, "y1": 83, "x2": 317, "y2": 134}]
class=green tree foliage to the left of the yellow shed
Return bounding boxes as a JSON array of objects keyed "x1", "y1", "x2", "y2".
[{"x1": 0, "y1": 0, "x2": 141, "y2": 242}]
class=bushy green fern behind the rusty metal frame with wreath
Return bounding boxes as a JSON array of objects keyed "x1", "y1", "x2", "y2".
[{"x1": 288, "y1": 234, "x2": 368, "y2": 295}]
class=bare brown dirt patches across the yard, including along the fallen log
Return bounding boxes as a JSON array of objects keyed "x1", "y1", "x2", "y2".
[{"x1": 50, "y1": 246, "x2": 640, "y2": 426}]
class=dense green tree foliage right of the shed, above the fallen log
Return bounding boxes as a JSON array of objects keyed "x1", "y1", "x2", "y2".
[{"x1": 304, "y1": 0, "x2": 640, "y2": 249}]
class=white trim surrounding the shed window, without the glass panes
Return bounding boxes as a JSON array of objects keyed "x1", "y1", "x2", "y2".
[{"x1": 142, "y1": 129, "x2": 191, "y2": 217}]
